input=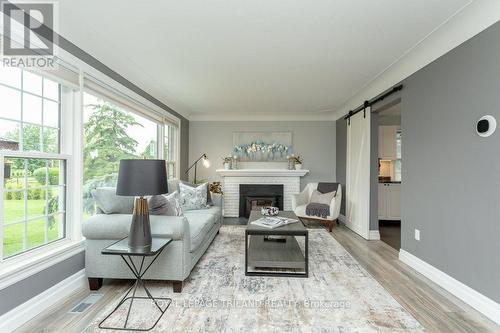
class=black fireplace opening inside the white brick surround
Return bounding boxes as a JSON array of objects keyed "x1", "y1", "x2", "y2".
[{"x1": 239, "y1": 184, "x2": 283, "y2": 217}]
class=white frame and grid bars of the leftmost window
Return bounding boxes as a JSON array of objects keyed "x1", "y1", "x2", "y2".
[{"x1": 0, "y1": 69, "x2": 78, "y2": 270}]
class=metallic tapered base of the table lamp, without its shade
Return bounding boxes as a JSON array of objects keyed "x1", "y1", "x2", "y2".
[{"x1": 128, "y1": 197, "x2": 152, "y2": 250}]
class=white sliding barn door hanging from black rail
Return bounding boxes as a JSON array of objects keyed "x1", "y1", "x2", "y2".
[{"x1": 346, "y1": 108, "x2": 371, "y2": 239}]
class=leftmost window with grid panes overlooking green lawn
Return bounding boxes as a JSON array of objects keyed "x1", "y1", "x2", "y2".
[{"x1": 0, "y1": 68, "x2": 67, "y2": 259}]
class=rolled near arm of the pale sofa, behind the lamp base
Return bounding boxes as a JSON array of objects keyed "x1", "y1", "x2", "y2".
[{"x1": 82, "y1": 214, "x2": 189, "y2": 240}]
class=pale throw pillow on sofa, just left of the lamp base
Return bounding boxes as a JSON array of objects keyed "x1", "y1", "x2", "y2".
[{"x1": 91, "y1": 187, "x2": 134, "y2": 214}]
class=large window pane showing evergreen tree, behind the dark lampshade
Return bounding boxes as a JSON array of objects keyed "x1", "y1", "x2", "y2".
[{"x1": 83, "y1": 93, "x2": 159, "y2": 217}]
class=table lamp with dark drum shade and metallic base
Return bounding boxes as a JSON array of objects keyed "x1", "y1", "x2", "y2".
[{"x1": 116, "y1": 160, "x2": 168, "y2": 251}]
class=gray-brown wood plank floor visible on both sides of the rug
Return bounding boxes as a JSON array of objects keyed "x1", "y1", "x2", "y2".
[{"x1": 13, "y1": 225, "x2": 500, "y2": 333}]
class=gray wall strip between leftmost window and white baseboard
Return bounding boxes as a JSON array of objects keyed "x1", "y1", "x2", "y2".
[{"x1": 0, "y1": 252, "x2": 85, "y2": 316}]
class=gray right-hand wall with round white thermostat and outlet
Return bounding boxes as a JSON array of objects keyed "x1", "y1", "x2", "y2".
[{"x1": 402, "y1": 23, "x2": 500, "y2": 302}]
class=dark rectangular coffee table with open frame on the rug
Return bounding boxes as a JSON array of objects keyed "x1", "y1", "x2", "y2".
[{"x1": 245, "y1": 210, "x2": 309, "y2": 277}]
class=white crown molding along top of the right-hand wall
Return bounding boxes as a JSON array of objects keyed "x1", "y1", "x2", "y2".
[{"x1": 333, "y1": 0, "x2": 500, "y2": 119}]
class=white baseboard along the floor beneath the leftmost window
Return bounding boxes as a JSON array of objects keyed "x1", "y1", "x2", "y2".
[{"x1": 0, "y1": 269, "x2": 87, "y2": 332}]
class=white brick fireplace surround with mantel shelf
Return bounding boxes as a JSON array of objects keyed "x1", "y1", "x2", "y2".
[{"x1": 216, "y1": 169, "x2": 309, "y2": 217}]
